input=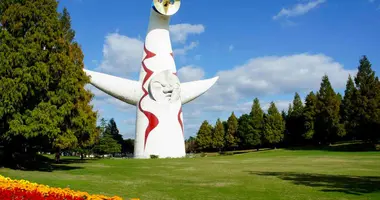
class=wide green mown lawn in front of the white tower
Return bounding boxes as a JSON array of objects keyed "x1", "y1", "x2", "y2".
[{"x1": 0, "y1": 149, "x2": 380, "y2": 200}]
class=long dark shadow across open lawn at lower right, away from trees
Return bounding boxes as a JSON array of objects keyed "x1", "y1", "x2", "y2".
[{"x1": 249, "y1": 171, "x2": 380, "y2": 195}]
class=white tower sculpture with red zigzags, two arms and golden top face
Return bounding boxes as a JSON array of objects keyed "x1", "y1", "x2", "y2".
[{"x1": 85, "y1": 0, "x2": 218, "y2": 158}]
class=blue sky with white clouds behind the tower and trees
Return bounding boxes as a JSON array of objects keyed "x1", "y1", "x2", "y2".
[{"x1": 59, "y1": 0, "x2": 380, "y2": 138}]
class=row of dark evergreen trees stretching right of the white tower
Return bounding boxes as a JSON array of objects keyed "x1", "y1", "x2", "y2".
[{"x1": 186, "y1": 56, "x2": 380, "y2": 152}]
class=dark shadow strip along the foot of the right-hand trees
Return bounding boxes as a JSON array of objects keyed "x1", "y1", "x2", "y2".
[{"x1": 285, "y1": 142, "x2": 379, "y2": 152}]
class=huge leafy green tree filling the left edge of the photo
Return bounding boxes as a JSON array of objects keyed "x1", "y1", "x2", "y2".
[{"x1": 0, "y1": 0, "x2": 97, "y2": 163}]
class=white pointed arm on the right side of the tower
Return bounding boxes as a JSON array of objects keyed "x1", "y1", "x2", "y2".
[{"x1": 181, "y1": 77, "x2": 219, "y2": 104}]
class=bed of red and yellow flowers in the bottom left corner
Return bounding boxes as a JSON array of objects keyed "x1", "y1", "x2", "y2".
[{"x1": 0, "y1": 175, "x2": 122, "y2": 200}]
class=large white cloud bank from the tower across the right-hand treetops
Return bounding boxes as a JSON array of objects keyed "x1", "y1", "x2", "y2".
[{"x1": 178, "y1": 53, "x2": 356, "y2": 137}]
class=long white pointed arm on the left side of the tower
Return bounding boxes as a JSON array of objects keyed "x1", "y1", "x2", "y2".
[{"x1": 84, "y1": 69, "x2": 142, "y2": 105}]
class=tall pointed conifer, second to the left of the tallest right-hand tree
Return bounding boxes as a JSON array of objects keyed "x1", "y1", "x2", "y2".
[{"x1": 315, "y1": 75, "x2": 345, "y2": 144}]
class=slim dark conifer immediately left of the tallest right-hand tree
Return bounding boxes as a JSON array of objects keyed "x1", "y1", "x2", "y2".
[{"x1": 340, "y1": 75, "x2": 357, "y2": 139}]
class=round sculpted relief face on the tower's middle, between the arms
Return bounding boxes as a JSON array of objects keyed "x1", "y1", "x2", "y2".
[{"x1": 149, "y1": 70, "x2": 181, "y2": 103}]
